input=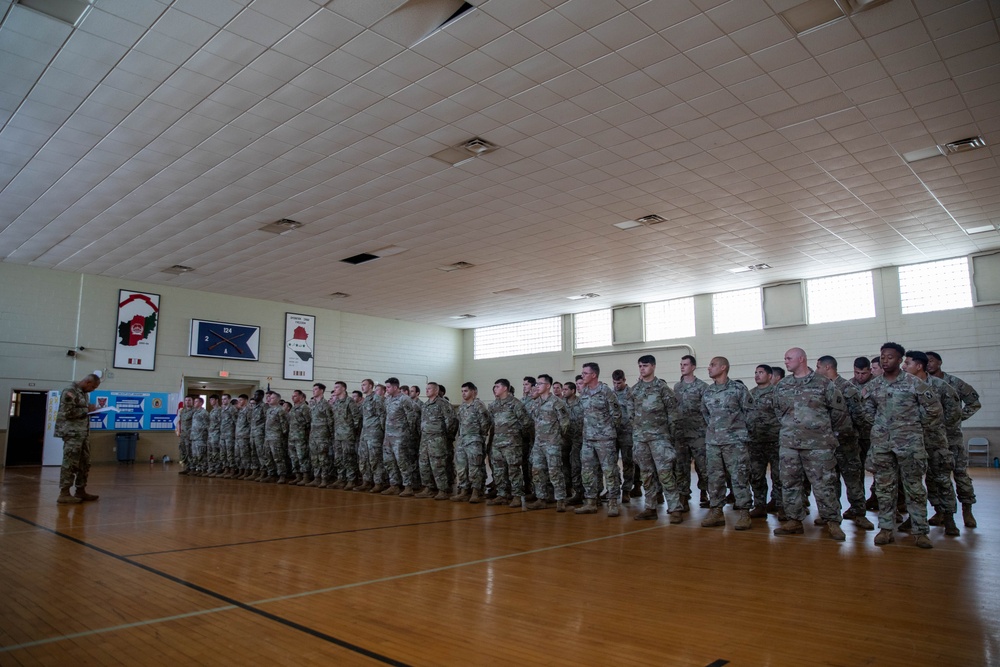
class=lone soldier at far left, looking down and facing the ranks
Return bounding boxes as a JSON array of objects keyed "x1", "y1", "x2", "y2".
[{"x1": 55, "y1": 373, "x2": 101, "y2": 505}]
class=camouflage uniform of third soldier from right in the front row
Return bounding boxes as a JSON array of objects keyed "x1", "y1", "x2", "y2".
[{"x1": 701, "y1": 379, "x2": 753, "y2": 510}]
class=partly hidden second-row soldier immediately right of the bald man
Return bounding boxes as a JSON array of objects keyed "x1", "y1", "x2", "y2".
[{"x1": 816, "y1": 355, "x2": 875, "y2": 530}]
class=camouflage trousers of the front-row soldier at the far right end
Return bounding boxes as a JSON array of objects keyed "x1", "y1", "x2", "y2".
[{"x1": 867, "y1": 444, "x2": 930, "y2": 535}]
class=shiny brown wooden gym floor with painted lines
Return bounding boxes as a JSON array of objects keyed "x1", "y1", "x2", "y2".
[{"x1": 0, "y1": 463, "x2": 1000, "y2": 667}]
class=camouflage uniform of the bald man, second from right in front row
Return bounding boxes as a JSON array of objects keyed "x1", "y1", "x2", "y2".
[{"x1": 774, "y1": 370, "x2": 848, "y2": 524}]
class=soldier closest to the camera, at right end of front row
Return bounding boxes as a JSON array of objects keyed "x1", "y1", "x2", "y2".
[{"x1": 861, "y1": 343, "x2": 941, "y2": 549}]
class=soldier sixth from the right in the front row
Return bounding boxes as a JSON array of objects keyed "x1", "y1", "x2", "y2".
[{"x1": 527, "y1": 373, "x2": 569, "y2": 512}]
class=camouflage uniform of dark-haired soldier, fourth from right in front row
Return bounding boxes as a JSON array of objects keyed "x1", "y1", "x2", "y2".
[{"x1": 632, "y1": 378, "x2": 681, "y2": 512}]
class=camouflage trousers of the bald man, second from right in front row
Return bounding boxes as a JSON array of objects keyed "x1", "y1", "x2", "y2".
[{"x1": 778, "y1": 447, "x2": 843, "y2": 523}]
